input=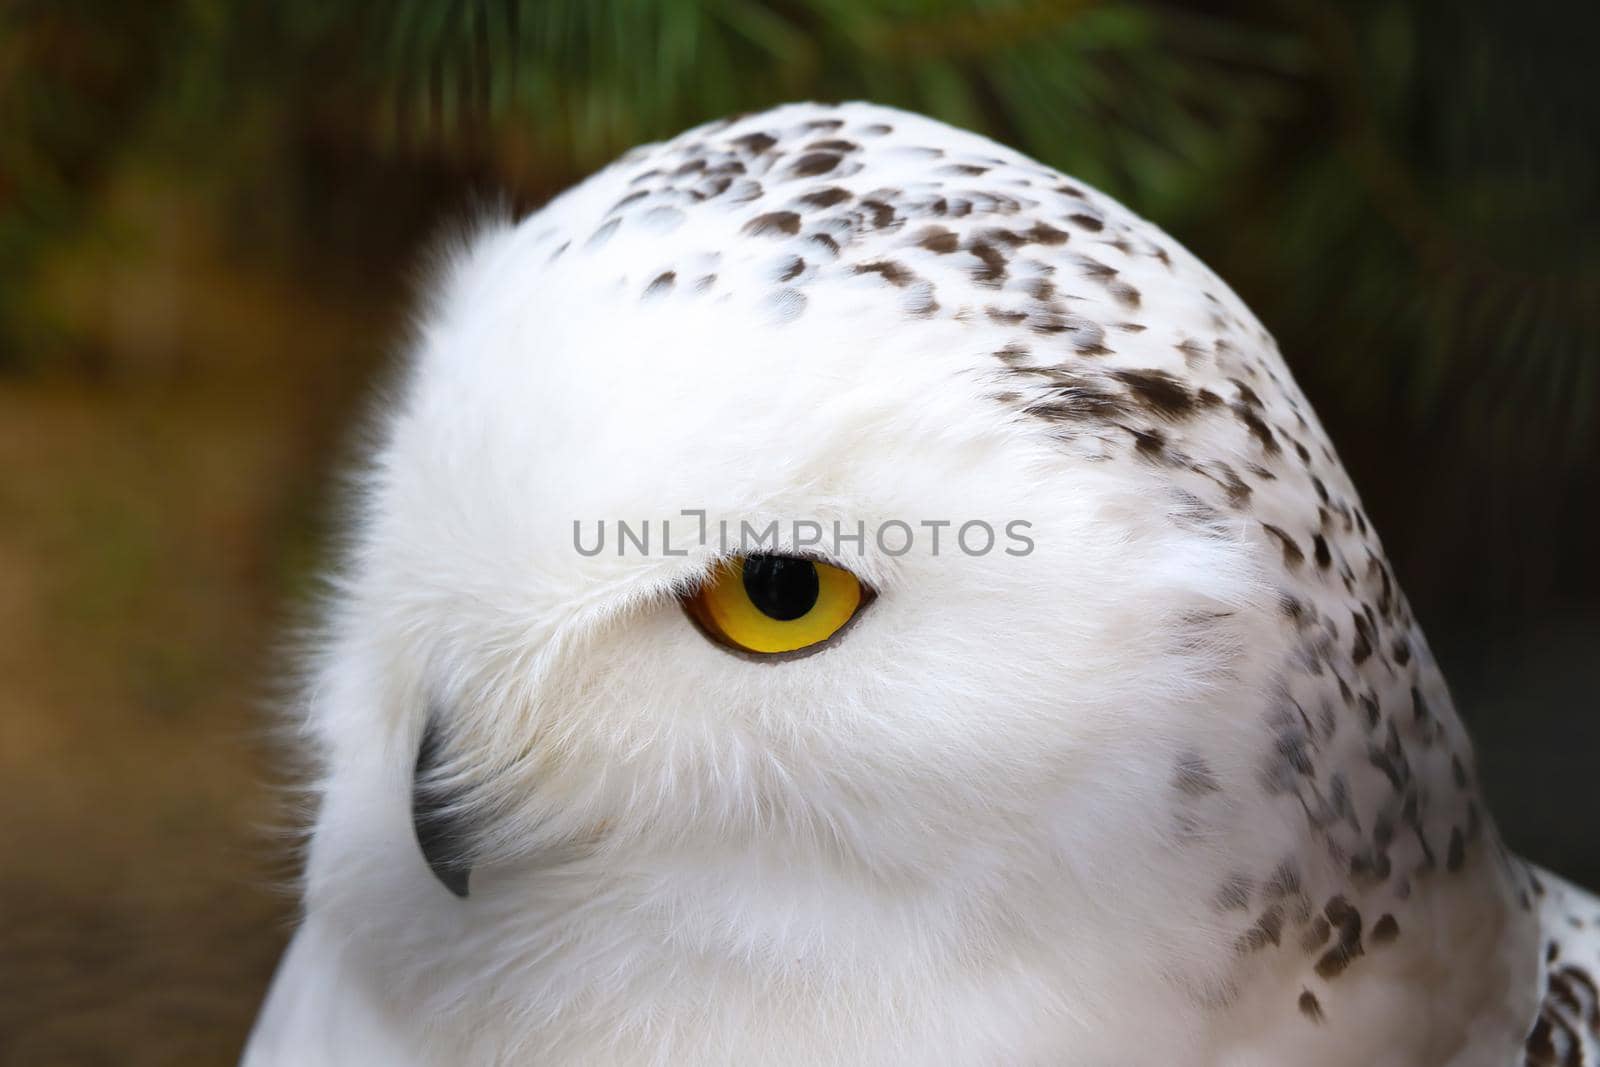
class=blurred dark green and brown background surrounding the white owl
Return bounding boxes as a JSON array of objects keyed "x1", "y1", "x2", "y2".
[{"x1": 0, "y1": 0, "x2": 1600, "y2": 1067}]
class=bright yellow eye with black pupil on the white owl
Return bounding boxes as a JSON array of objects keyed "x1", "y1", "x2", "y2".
[{"x1": 685, "y1": 555, "x2": 866, "y2": 654}]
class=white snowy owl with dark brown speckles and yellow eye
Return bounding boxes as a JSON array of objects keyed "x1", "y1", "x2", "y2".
[{"x1": 245, "y1": 104, "x2": 1600, "y2": 1067}]
